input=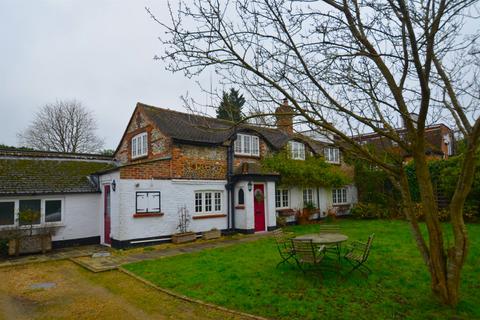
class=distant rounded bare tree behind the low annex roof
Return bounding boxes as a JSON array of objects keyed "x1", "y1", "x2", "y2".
[{"x1": 18, "y1": 100, "x2": 103, "y2": 153}]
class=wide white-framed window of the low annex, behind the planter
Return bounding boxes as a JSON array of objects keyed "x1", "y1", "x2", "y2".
[{"x1": 0, "y1": 199, "x2": 63, "y2": 227}]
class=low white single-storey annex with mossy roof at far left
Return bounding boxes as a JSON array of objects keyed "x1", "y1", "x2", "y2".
[{"x1": 0, "y1": 150, "x2": 114, "y2": 247}]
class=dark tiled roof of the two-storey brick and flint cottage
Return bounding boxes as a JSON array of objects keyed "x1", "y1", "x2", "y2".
[{"x1": 137, "y1": 103, "x2": 325, "y2": 153}]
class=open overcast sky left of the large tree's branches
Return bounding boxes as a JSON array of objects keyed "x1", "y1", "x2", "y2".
[{"x1": 0, "y1": 0, "x2": 210, "y2": 149}]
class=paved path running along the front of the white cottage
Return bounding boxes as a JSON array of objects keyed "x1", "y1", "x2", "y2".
[{"x1": 70, "y1": 232, "x2": 270, "y2": 272}]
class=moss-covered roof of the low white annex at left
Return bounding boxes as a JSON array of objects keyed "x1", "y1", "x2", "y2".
[{"x1": 0, "y1": 149, "x2": 115, "y2": 196}]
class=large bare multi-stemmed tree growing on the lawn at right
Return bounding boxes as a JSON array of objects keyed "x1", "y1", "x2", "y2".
[{"x1": 152, "y1": 0, "x2": 480, "y2": 305}]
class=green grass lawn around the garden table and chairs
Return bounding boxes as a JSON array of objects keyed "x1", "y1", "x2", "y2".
[{"x1": 122, "y1": 220, "x2": 480, "y2": 319}]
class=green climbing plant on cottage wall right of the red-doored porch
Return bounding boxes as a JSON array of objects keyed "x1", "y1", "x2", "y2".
[{"x1": 262, "y1": 152, "x2": 352, "y2": 187}]
